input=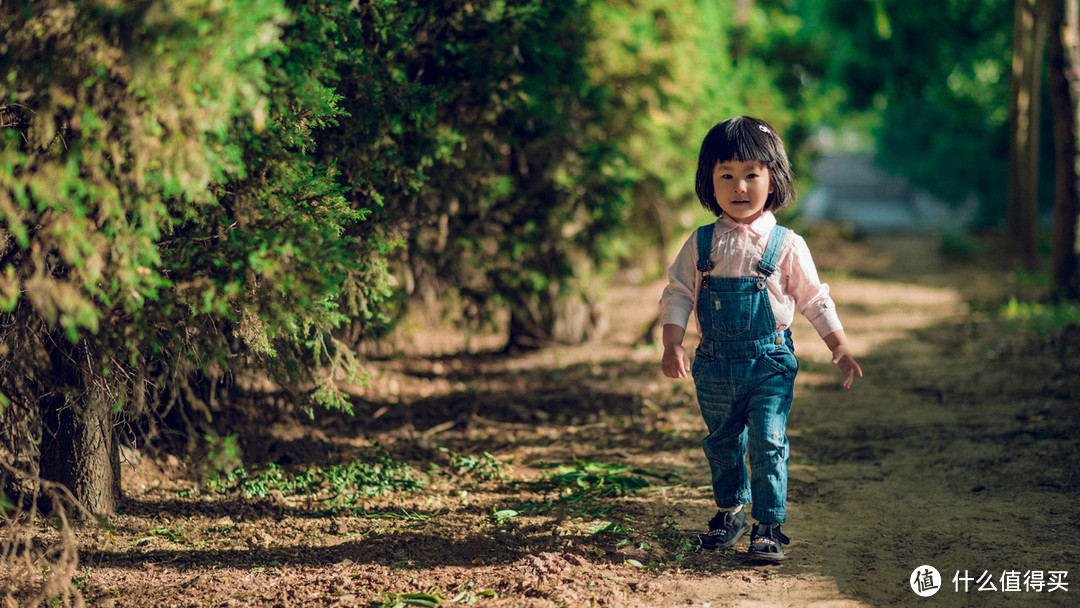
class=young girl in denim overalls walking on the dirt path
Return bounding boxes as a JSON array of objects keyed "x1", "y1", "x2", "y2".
[{"x1": 660, "y1": 117, "x2": 863, "y2": 562}]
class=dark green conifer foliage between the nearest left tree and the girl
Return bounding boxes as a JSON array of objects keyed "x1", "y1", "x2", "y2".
[{"x1": 320, "y1": 0, "x2": 629, "y2": 345}]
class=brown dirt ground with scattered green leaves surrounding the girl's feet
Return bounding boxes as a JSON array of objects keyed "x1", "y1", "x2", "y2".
[{"x1": 50, "y1": 234, "x2": 1080, "y2": 608}]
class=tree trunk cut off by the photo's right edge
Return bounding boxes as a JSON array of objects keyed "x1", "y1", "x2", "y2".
[{"x1": 1048, "y1": 0, "x2": 1080, "y2": 299}]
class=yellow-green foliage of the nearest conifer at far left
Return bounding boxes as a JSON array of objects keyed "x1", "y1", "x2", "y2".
[{"x1": 0, "y1": 0, "x2": 389, "y2": 429}]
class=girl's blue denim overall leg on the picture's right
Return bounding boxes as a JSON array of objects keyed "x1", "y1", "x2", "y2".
[{"x1": 746, "y1": 360, "x2": 795, "y2": 524}]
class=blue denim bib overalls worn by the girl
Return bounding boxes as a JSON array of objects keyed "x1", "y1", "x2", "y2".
[{"x1": 692, "y1": 224, "x2": 798, "y2": 524}]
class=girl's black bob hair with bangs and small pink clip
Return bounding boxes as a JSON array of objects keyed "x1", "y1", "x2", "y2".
[{"x1": 694, "y1": 117, "x2": 795, "y2": 217}]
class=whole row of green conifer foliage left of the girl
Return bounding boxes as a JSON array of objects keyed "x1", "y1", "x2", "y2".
[{"x1": 0, "y1": 0, "x2": 842, "y2": 423}]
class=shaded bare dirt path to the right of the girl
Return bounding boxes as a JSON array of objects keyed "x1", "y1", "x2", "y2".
[{"x1": 792, "y1": 238, "x2": 1080, "y2": 606}]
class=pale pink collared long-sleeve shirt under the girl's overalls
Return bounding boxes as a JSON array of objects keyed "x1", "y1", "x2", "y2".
[{"x1": 660, "y1": 212, "x2": 842, "y2": 338}]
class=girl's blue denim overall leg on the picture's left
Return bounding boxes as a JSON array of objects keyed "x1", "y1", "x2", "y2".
[{"x1": 693, "y1": 356, "x2": 751, "y2": 509}]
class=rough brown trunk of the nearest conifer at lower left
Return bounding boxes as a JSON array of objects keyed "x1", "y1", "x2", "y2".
[{"x1": 39, "y1": 338, "x2": 120, "y2": 515}]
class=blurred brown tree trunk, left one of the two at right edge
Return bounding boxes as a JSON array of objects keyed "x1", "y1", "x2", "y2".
[{"x1": 1008, "y1": 0, "x2": 1045, "y2": 267}]
